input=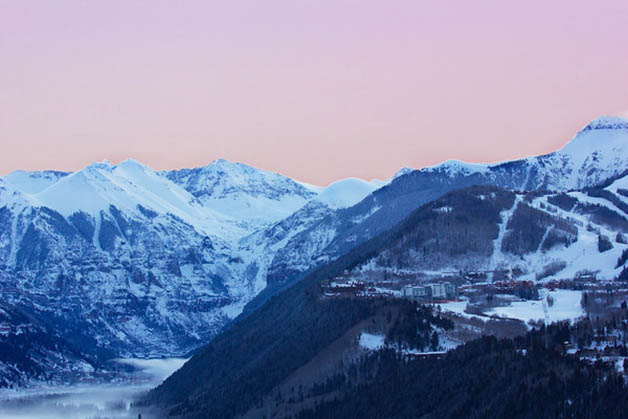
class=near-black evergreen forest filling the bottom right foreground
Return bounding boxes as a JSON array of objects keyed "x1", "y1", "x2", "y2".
[{"x1": 298, "y1": 324, "x2": 628, "y2": 419}]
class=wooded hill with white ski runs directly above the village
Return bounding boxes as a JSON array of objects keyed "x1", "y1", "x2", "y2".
[{"x1": 349, "y1": 180, "x2": 628, "y2": 281}]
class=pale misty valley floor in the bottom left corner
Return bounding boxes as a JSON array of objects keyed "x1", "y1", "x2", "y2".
[{"x1": 0, "y1": 358, "x2": 186, "y2": 419}]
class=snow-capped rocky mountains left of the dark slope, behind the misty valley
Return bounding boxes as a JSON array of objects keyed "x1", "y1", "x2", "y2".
[{"x1": 0, "y1": 160, "x2": 376, "y2": 358}]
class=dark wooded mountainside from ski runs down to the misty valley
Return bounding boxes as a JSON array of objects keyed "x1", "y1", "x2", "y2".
[{"x1": 144, "y1": 185, "x2": 628, "y2": 418}]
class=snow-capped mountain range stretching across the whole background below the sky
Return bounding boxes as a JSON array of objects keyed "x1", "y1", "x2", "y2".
[{"x1": 0, "y1": 117, "x2": 628, "y2": 390}]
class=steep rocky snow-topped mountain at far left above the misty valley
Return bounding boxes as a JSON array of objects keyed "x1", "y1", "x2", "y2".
[{"x1": 0, "y1": 161, "x2": 245, "y2": 355}]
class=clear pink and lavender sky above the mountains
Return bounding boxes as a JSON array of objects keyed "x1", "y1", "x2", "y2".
[{"x1": 0, "y1": 0, "x2": 628, "y2": 185}]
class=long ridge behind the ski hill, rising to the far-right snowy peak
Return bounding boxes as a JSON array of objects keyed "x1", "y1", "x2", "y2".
[{"x1": 253, "y1": 117, "x2": 628, "y2": 296}]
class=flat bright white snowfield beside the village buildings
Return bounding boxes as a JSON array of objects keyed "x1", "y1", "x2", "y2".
[{"x1": 486, "y1": 290, "x2": 585, "y2": 324}]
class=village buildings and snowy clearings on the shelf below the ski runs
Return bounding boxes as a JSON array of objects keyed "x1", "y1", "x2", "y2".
[{"x1": 322, "y1": 270, "x2": 628, "y2": 373}]
